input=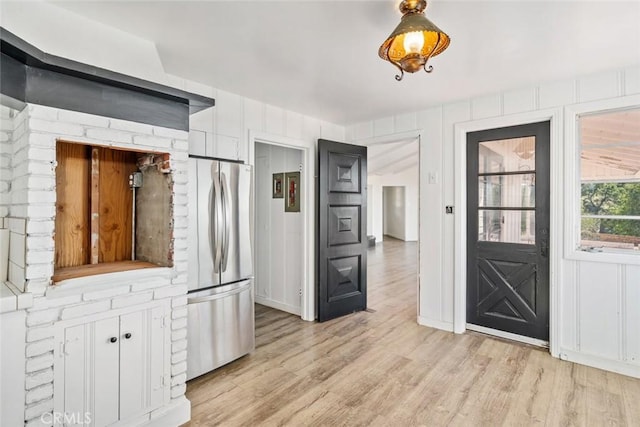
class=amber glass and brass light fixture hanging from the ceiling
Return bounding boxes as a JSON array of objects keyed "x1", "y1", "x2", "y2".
[{"x1": 378, "y1": 0, "x2": 450, "y2": 81}]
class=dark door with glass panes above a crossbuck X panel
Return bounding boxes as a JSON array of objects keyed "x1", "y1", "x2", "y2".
[{"x1": 467, "y1": 122, "x2": 550, "y2": 341}]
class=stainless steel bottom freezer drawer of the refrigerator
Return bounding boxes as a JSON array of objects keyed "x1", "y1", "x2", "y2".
[{"x1": 187, "y1": 280, "x2": 255, "y2": 379}]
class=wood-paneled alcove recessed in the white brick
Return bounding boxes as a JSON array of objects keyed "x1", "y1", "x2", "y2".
[{"x1": 53, "y1": 141, "x2": 172, "y2": 282}]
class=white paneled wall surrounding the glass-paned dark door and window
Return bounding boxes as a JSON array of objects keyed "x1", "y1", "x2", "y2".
[{"x1": 347, "y1": 65, "x2": 640, "y2": 376}]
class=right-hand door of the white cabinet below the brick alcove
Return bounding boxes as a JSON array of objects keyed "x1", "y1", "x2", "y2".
[{"x1": 120, "y1": 307, "x2": 164, "y2": 420}]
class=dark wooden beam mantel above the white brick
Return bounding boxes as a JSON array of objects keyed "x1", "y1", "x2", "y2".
[{"x1": 0, "y1": 27, "x2": 215, "y2": 130}]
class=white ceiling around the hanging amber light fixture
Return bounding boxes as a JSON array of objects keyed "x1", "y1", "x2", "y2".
[{"x1": 48, "y1": 0, "x2": 640, "y2": 125}]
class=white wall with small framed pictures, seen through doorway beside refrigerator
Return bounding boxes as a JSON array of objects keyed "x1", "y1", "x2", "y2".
[{"x1": 255, "y1": 143, "x2": 304, "y2": 315}]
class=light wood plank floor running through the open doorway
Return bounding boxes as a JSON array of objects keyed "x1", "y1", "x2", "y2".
[{"x1": 187, "y1": 240, "x2": 640, "y2": 426}]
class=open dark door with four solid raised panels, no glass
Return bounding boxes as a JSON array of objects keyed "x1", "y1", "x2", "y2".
[{"x1": 317, "y1": 139, "x2": 367, "y2": 322}]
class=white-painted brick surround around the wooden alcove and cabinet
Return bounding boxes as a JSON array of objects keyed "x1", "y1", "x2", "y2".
[{"x1": 10, "y1": 105, "x2": 188, "y2": 425}]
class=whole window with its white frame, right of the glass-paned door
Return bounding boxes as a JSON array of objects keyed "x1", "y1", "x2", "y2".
[{"x1": 565, "y1": 96, "x2": 640, "y2": 264}]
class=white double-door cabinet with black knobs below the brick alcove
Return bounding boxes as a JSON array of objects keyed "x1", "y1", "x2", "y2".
[{"x1": 54, "y1": 304, "x2": 171, "y2": 426}]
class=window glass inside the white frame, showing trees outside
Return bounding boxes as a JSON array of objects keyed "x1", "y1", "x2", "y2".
[{"x1": 578, "y1": 106, "x2": 640, "y2": 251}]
